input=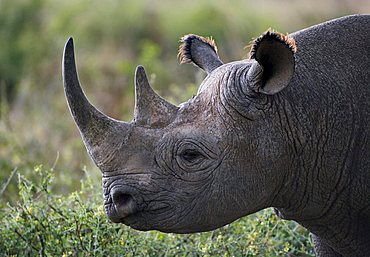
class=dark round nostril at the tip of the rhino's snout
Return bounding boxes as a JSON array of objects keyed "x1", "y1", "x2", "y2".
[{"x1": 111, "y1": 189, "x2": 136, "y2": 219}]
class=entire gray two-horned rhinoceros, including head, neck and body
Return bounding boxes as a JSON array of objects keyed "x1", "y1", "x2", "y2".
[{"x1": 63, "y1": 15, "x2": 370, "y2": 256}]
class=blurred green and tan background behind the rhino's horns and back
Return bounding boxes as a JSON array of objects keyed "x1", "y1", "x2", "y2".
[{"x1": 0, "y1": 0, "x2": 370, "y2": 254}]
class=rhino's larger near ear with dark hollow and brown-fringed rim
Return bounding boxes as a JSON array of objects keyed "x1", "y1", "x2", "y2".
[{"x1": 248, "y1": 31, "x2": 297, "y2": 95}]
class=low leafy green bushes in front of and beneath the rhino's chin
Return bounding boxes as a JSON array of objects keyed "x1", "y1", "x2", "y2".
[{"x1": 0, "y1": 166, "x2": 313, "y2": 256}]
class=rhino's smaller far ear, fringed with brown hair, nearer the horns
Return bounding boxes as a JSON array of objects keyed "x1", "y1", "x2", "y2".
[{"x1": 177, "y1": 34, "x2": 223, "y2": 74}]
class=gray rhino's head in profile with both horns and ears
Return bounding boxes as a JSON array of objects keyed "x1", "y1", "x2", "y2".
[{"x1": 63, "y1": 32, "x2": 295, "y2": 233}]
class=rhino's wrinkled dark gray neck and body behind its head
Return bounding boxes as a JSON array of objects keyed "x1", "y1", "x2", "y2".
[{"x1": 274, "y1": 16, "x2": 370, "y2": 255}]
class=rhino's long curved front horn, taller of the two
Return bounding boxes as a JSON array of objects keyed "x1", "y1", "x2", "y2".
[{"x1": 62, "y1": 38, "x2": 132, "y2": 168}]
